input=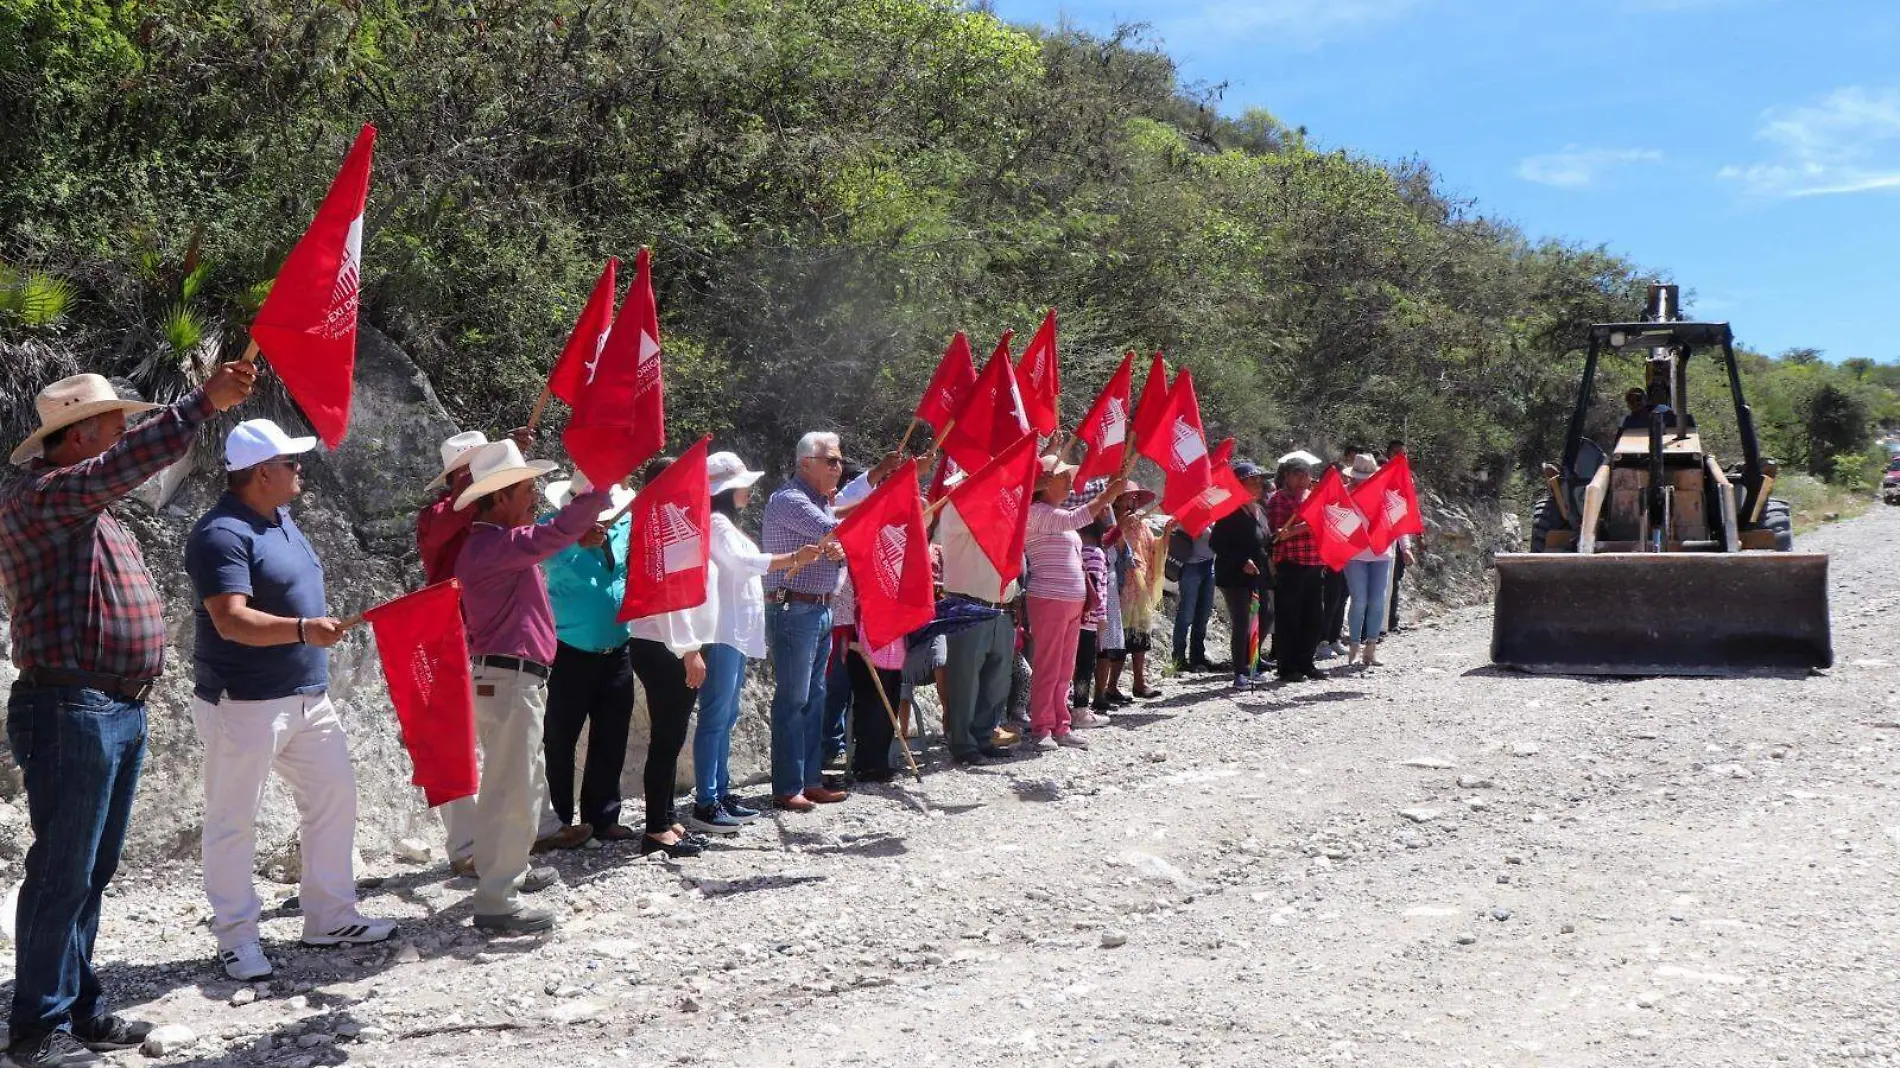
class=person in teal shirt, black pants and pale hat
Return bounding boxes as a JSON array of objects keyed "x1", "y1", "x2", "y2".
[{"x1": 536, "y1": 475, "x2": 635, "y2": 849}]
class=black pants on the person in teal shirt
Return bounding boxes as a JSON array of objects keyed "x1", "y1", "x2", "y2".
[{"x1": 542, "y1": 644, "x2": 633, "y2": 830}]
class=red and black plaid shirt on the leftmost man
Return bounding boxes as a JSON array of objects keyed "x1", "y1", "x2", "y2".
[{"x1": 0, "y1": 390, "x2": 213, "y2": 678}]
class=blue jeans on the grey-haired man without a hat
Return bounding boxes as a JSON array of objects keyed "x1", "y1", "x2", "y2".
[{"x1": 766, "y1": 601, "x2": 830, "y2": 798}]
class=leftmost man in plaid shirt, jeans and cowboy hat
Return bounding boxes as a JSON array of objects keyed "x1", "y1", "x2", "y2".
[{"x1": 0, "y1": 363, "x2": 257, "y2": 1068}]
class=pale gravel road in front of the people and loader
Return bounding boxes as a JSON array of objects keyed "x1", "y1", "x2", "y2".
[{"x1": 3, "y1": 509, "x2": 1900, "y2": 1068}]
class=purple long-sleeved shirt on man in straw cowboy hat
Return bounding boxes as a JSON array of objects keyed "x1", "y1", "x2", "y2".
[{"x1": 456, "y1": 492, "x2": 610, "y2": 665}]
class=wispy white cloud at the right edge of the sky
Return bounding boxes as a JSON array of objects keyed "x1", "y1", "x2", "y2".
[{"x1": 1718, "y1": 86, "x2": 1900, "y2": 196}]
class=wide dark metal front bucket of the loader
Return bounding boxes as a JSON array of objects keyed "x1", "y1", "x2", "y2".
[{"x1": 1492, "y1": 553, "x2": 1834, "y2": 675}]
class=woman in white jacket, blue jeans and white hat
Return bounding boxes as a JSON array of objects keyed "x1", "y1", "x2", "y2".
[{"x1": 691, "y1": 452, "x2": 823, "y2": 834}]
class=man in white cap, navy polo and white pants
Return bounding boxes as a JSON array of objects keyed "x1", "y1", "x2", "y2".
[{"x1": 184, "y1": 420, "x2": 395, "y2": 982}]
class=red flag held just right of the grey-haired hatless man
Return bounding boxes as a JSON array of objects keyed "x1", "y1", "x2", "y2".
[{"x1": 834, "y1": 460, "x2": 937, "y2": 648}]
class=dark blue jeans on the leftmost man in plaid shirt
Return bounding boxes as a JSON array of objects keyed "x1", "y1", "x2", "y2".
[{"x1": 6, "y1": 686, "x2": 144, "y2": 1041}]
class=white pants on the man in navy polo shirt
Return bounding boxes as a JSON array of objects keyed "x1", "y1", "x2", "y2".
[{"x1": 192, "y1": 694, "x2": 357, "y2": 950}]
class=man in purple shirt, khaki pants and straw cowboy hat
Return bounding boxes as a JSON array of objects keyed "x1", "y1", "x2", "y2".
[{"x1": 454, "y1": 439, "x2": 612, "y2": 935}]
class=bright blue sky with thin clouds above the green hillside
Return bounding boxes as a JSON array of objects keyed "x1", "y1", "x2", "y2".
[{"x1": 994, "y1": 0, "x2": 1900, "y2": 361}]
